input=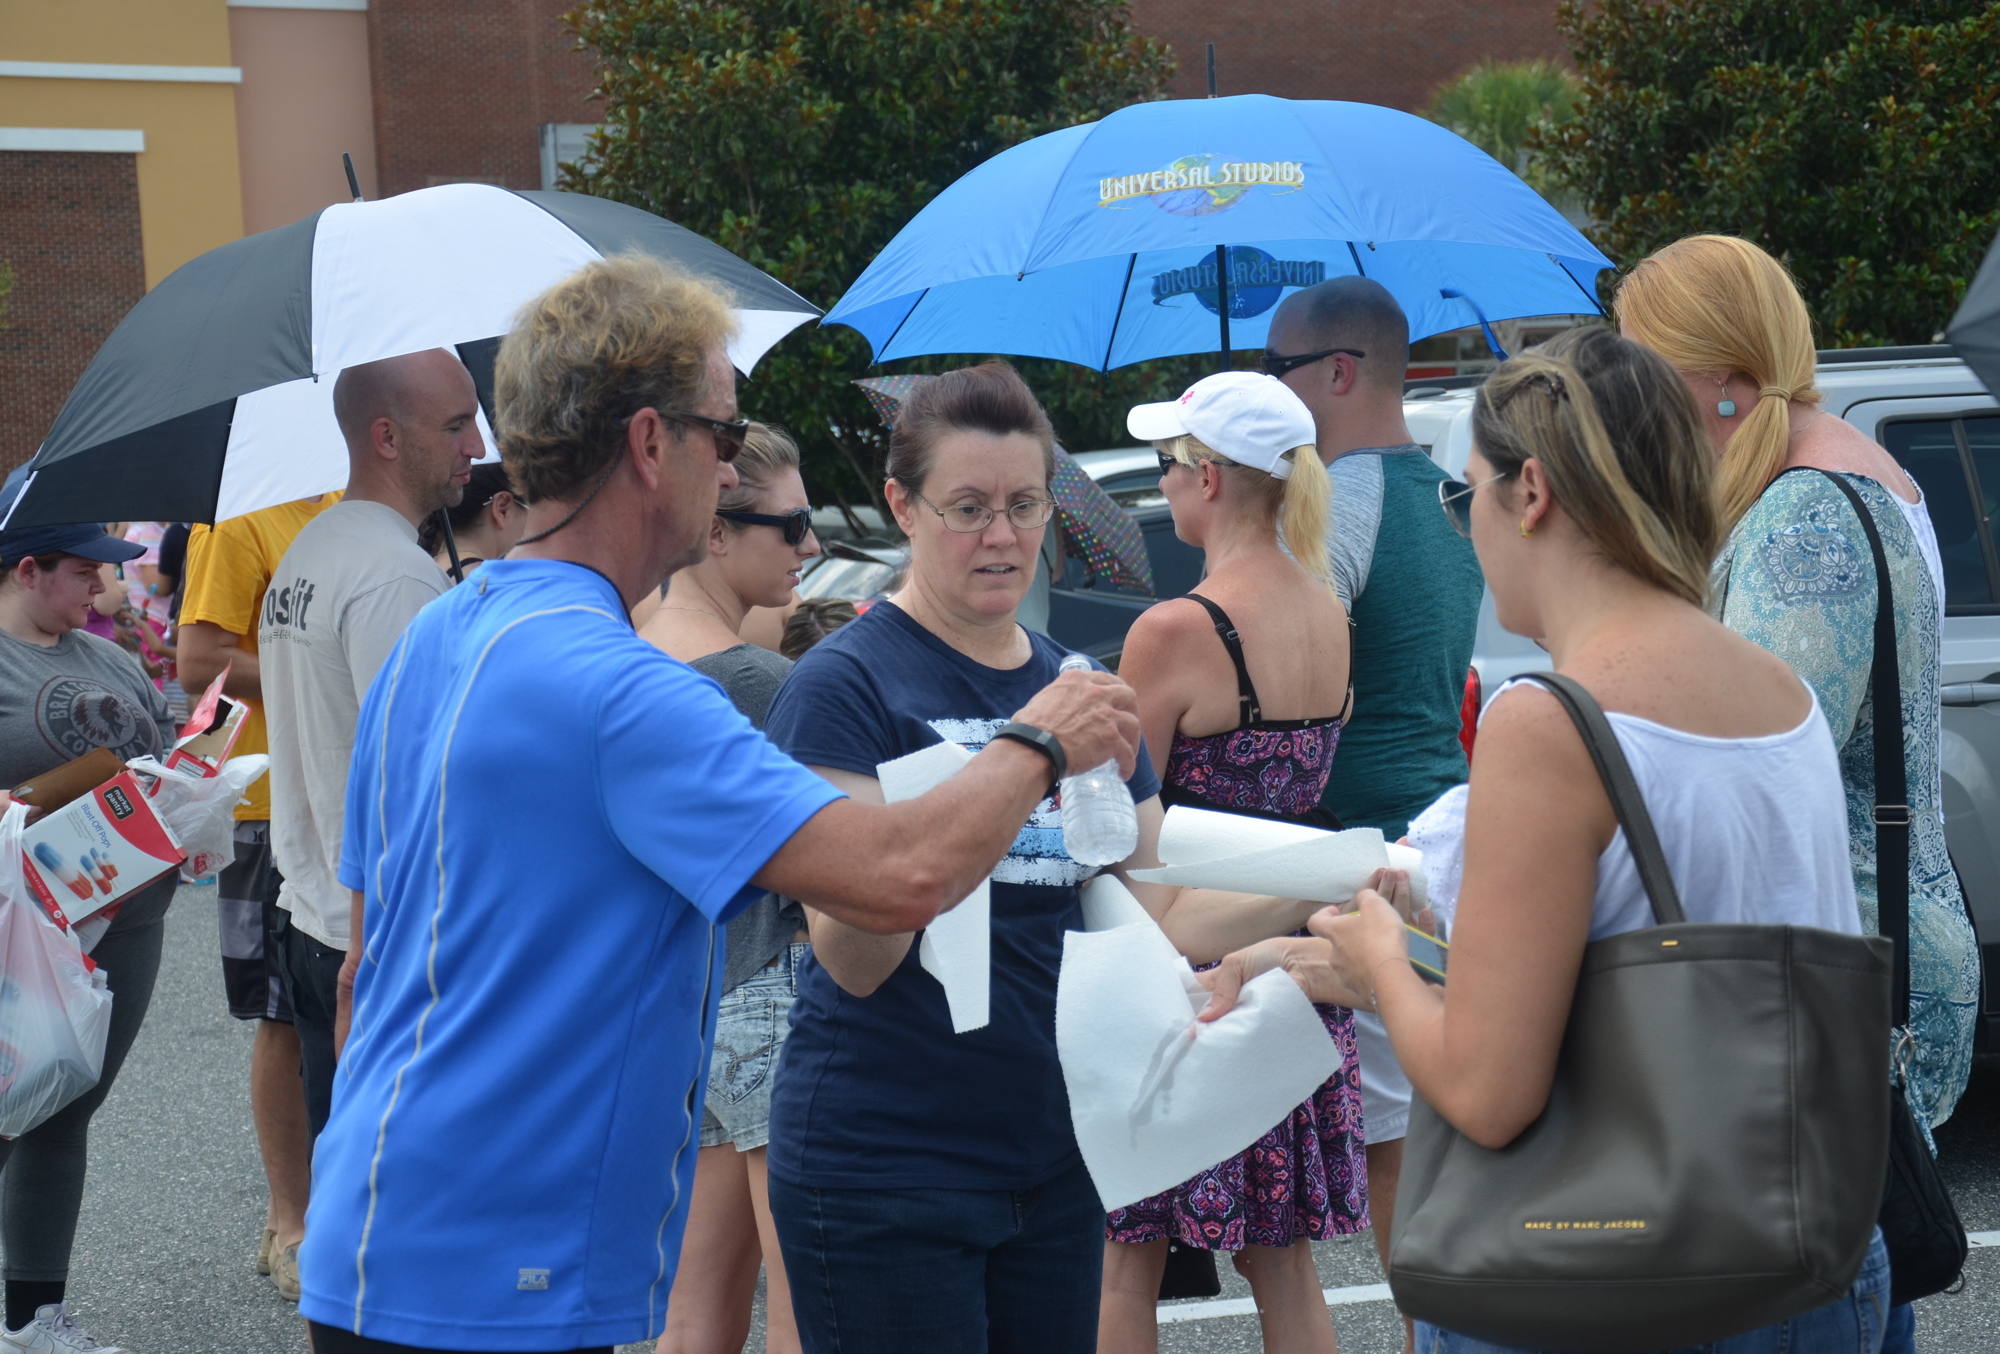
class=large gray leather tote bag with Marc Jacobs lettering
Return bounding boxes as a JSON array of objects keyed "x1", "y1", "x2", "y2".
[{"x1": 1390, "y1": 674, "x2": 1890, "y2": 1354}]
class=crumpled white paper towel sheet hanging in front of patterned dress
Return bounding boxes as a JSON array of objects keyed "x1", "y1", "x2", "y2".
[{"x1": 1056, "y1": 924, "x2": 1340, "y2": 1212}]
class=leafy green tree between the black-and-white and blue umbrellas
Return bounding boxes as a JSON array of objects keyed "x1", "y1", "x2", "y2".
[{"x1": 562, "y1": 0, "x2": 1174, "y2": 504}]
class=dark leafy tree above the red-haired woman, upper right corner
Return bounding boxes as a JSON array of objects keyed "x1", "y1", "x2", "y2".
[{"x1": 1540, "y1": 0, "x2": 2000, "y2": 346}]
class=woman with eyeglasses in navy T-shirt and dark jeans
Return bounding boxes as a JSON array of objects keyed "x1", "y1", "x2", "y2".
[{"x1": 768, "y1": 362, "x2": 1158, "y2": 1354}]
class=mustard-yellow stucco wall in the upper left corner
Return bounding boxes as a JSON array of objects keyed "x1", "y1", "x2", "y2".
[{"x1": 0, "y1": 0, "x2": 244, "y2": 286}]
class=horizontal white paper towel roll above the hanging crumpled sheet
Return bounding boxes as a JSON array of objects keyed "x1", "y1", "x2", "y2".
[{"x1": 1132, "y1": 804, "x2": 1426, "y2": 906}]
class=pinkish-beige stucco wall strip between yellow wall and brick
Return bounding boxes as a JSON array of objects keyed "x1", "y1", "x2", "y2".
[{"x1": 228, "y1": 8, "x2": 376, "y2": 234}]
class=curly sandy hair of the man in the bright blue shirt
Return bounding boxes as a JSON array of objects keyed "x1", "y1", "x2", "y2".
[{"x1": 494, "y1": 254, "x2": 736, "y2": 502}]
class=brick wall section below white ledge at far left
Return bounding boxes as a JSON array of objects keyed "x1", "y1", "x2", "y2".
[{"x1": 0, "y1": 150, "x2": 146, "y2": 474}]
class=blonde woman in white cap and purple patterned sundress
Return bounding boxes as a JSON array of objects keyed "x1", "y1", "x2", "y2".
[{"x1": 1098, "y1": 372, "x2": 1368, "y2": 1354}]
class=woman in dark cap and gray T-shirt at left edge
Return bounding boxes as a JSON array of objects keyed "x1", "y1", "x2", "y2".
[{"x1": 0, "y1": 524, "x2": 178, "y2": 1354}]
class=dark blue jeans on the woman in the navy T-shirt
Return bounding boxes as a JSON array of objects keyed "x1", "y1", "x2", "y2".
[{"x1": 770, "y1": 1164, "x2": 1104, "y2": 1354}]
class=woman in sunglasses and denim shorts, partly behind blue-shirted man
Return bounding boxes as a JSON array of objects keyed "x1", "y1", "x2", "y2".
[{"x1": 640, "y1": 422, "x2": 820, "y2": 1354}]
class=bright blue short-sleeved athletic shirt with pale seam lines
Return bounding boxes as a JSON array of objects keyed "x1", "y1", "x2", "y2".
[{"x1": 300, "y1": 560, "x2": 840, "y2": 1350}]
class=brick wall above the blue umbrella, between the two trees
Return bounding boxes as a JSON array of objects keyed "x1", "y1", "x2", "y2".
[{"x1": 1132, "y1": 0, "x2": 1568, "y2": 112}]
